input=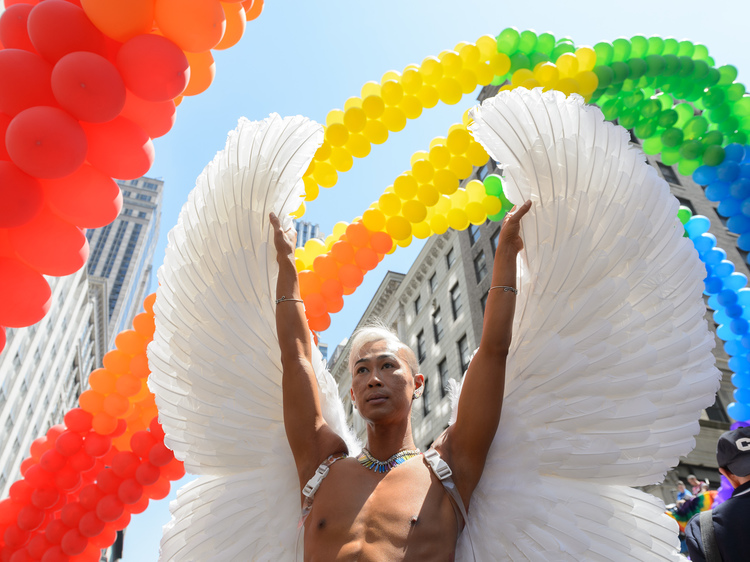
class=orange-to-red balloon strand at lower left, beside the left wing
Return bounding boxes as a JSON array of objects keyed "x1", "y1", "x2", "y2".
[{"x1": 0, "y1": 295, "x2": 185, "y2": 562}]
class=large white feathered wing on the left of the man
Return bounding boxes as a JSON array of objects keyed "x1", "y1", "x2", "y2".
[{"x1": 149, "y1": 114, "x2": 358, "y2": 561}]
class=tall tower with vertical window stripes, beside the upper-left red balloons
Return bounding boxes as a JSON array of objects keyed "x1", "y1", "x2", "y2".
[{"x1": 87, "y1": 177, "x2": 164, "y2": 349}]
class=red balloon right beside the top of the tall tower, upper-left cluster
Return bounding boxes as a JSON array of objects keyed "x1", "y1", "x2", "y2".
[{"x1": 41, "y1": 163, "x2": 122, "y2": 228}]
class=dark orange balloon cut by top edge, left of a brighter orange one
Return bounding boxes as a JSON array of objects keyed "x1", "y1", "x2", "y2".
[{"x1": 81, "y1": 0, "x2": 154, "y2": 43}]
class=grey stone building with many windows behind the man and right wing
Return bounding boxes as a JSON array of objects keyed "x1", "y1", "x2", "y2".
[{"x1": 330, "y1": 86, "x2": 736, "y2": 504}]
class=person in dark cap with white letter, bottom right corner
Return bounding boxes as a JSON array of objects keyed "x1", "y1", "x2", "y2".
[{"x1": 685, "y1": 427, "x2": 750, "y2": 562}]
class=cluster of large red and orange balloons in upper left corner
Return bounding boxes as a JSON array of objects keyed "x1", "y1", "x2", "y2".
[{"x1": 0, "y1": 0, "x2": 263, "y2": 350}]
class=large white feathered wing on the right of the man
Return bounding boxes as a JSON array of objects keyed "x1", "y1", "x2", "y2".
[{"x1": 452, "y1": 89, "x2": 720, "y2": 561}]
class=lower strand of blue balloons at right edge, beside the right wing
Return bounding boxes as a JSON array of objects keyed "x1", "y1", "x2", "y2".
[{"x1": 678, "y1": 207, "x2": 750, "y2": 421}]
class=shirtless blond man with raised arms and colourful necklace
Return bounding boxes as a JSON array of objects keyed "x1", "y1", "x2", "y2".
[{"x1": 271, "y1": 201, "x2": 531, "y2": 562}]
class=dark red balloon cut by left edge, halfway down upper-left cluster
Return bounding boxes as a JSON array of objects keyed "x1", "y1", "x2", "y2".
[{"x1": 0, "y1": 161, "x2": 44, "y2": 228}]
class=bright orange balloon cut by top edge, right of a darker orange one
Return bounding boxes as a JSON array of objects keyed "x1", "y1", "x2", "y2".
[{"x1": 154, "y1": 0, "x2": 227, "y2": 53}]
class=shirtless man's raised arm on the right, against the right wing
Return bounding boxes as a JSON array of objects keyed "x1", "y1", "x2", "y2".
[{"x1": 436, "y1": 201, "x2": 531, "y2": 500}]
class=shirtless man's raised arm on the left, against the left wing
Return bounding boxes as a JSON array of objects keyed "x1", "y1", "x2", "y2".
[{"x1": 270, "y1": 213, "x2": 347, "y2": 485}]
